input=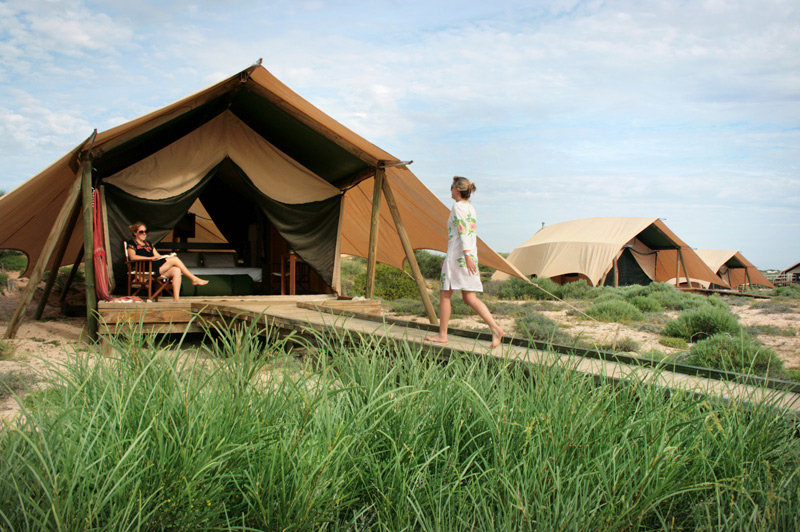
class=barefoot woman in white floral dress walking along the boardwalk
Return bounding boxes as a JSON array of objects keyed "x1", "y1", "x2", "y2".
[{"x1": 425, "y1": 176, "x2": 505, "y2": 348}]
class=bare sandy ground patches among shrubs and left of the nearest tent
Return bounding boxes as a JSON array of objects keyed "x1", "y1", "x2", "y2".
[{"x1": 0, "y1": 273, "x2": 800, "y2": 422}]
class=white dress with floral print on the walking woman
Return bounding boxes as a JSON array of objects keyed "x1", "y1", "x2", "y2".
[{"x1": 441, "y1": 201, "x2": 483, "y2": 292}]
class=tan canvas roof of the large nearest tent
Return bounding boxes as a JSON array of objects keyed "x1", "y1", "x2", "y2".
[{"x1": 0, "y1": 65, "x2": 519, "y2": 284}]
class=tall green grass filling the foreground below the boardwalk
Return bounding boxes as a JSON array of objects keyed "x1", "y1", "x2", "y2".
[{"x1": 0, "y1": 326, "x2": 800, "y2": 531}]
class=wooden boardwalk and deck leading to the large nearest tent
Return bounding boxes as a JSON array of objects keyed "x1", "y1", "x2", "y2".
[{"x1": 99, "y1": 296, "x2": 800, "y2": 418}]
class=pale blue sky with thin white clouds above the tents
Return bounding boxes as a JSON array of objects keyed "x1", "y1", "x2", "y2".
[{"x1": 0, "y1": 0, "x2": 800, "y2": 269}]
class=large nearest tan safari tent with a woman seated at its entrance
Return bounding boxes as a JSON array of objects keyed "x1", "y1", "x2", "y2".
[{"x1": 0, "y1": 62, "x2": 519, "y2": 336}]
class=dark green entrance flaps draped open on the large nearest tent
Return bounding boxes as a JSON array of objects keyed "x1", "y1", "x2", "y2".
[{"x1": 101, "y1": 158, "x2": 341, "y2": 293}]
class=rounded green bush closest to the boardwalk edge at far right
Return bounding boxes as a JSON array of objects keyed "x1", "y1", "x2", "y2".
[{"x1": 686, "y1": 333, "x2": 783, "y2": 375}]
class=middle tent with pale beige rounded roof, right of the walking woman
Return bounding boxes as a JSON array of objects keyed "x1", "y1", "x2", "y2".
[{"x1": 492, "y1": 217, "x2": 727, "y2": 286}]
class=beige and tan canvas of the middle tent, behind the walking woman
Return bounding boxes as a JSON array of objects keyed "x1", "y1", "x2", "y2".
[{"x1": 492, "y1": 217, "x2": 726, "y2": 286}]
